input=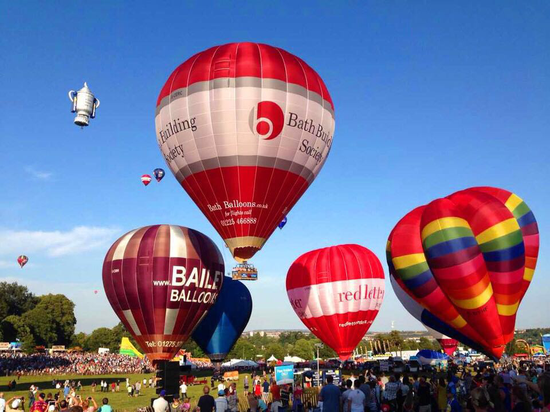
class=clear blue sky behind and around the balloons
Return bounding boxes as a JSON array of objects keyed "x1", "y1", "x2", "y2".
[{"x1": 0, "y1": 0, "x2": 550, "y2": 332}]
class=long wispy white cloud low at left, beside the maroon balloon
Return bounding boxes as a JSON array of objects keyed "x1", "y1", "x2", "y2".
[{"x1": 0, "y1": 226, "x2": 118, "y2": 256}]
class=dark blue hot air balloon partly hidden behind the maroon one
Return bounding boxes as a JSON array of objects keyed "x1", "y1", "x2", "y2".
[{"x1": 192, "y1": 277, "x2": 252, "y2": 364}]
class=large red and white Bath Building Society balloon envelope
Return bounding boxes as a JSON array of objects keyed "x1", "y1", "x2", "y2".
[{"x1": 155, "y1": 43, "x2": 334, "y2": 262}]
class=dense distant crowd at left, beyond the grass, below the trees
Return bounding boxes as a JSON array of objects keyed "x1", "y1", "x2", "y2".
[{"x1": 0, "y1": 352, "x2": 153, "y2": 376}]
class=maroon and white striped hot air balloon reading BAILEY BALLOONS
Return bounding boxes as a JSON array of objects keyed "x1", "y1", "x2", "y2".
[{"x1": 103, "y1": 225, "x2": 224, "y2": 362}]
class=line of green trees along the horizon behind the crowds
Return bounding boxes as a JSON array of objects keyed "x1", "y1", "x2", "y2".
[{"x1": 0, "y1": 282, "x2": 550, "y2": 360}]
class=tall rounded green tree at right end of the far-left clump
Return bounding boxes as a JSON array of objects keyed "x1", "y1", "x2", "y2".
[{"x1": 22, "y1": 294, "x2": 76, "y2": 347}]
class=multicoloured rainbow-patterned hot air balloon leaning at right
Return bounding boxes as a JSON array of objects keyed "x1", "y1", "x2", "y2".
[{"x1": 387, "y1": 187, "x2": 539, "y2": 359}]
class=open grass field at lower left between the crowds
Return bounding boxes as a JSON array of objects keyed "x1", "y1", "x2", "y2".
[{"x1": 0, "y1": 374, "x2": 254, "y2": 412}]
